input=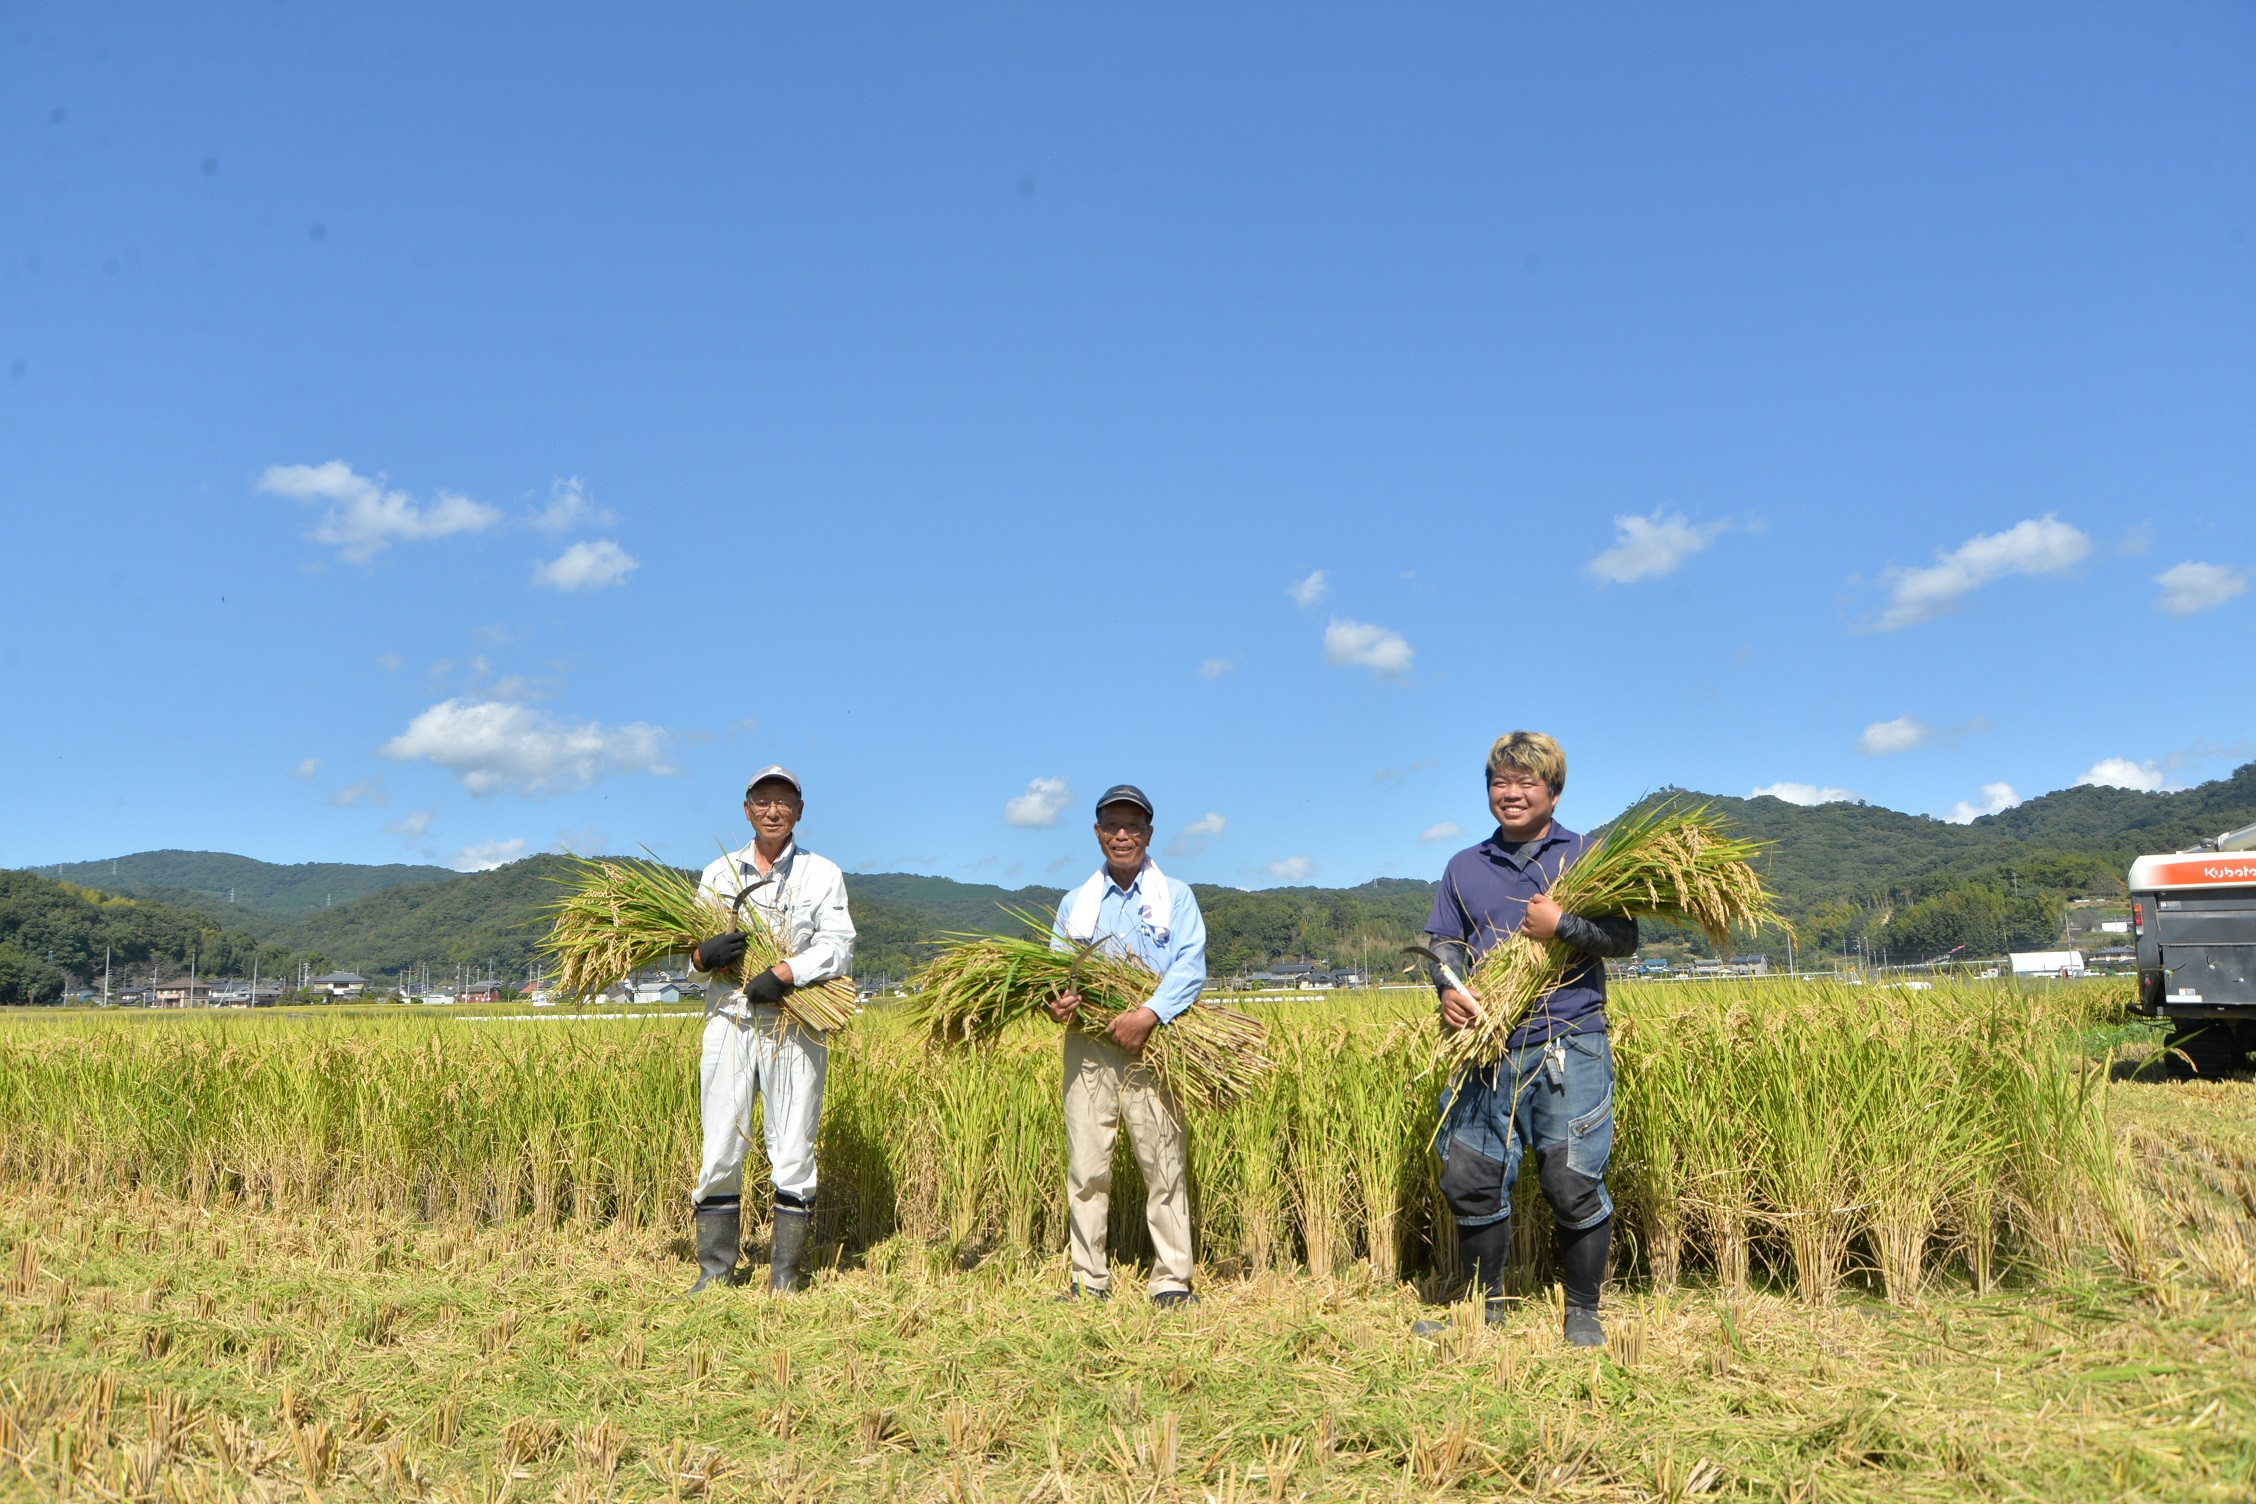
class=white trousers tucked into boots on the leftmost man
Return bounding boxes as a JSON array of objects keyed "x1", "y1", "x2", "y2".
[{"x1": 690, "y1": 1006, "x2": 830, "y2": 1206}]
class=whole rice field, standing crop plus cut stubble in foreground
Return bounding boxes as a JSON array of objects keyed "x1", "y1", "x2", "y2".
[{"x1": 0, "y1": 983, "x2": 2256, "y2": 1502}]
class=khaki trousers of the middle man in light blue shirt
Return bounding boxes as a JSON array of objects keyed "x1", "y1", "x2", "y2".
[{"x1": 1065, "y1": 1024, "x2": 1191, "y2": 1294}]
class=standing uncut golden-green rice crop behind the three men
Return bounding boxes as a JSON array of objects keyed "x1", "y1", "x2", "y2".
[{"x1": 0, "y1": 979, "x2": 2127, "y2": 1301}]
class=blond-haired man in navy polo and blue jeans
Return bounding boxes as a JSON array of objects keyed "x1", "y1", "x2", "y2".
[{"x1": 1419, "y1": 731, "x2": 1638, "y2": 1346}]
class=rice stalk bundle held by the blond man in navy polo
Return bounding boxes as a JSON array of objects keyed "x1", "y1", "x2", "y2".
[{"x1": 1442, "y1": 798, "x2": 1784, "y2": 1069}]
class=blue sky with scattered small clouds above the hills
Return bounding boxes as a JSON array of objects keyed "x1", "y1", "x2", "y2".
[{"x1": 0, "y1": 5, "x2": 2256, "y2": 886}]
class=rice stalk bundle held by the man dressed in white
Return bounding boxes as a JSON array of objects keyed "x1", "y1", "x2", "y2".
[{"x1": 541, "y1": 857, "x2": 860, "y2": 1033}]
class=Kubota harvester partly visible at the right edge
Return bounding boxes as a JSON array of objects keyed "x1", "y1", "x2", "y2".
[{"x1": 2130, "y1": 825, "x2": 2256, "y2": 1076}]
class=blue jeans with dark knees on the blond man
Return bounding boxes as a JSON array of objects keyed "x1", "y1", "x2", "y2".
[{"x1": 1433, "y1": 1028, "x2": 1613, "y2": 1231}]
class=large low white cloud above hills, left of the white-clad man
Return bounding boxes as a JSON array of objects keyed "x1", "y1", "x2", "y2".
[{"x1": 377, "y1": 699, "x2": 675, "y2": 794}]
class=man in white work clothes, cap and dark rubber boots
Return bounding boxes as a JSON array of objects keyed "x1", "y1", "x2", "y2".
[{"x1": 690, "y1": 767, "x2": 853, "y2": 1294}]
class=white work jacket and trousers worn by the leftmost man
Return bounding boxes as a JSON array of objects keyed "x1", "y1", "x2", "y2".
[{"x1": 690, "y1": 841, "x2": 853, "y2": 1209}]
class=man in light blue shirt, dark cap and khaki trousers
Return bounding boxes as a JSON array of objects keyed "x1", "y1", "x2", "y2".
[{"x1": 1049, "y1": 782, "x2": 1207, "y2": 1306}]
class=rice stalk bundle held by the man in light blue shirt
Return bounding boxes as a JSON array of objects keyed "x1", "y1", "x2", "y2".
[{"x1": 909, "y1": 909, "x2": 1270, "y2": 1112}]
